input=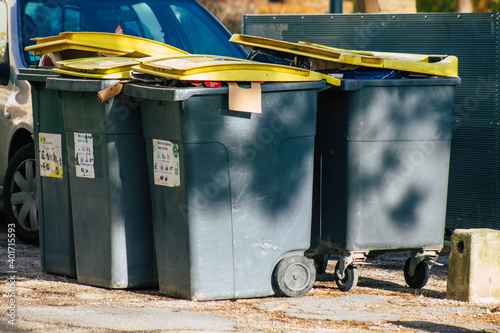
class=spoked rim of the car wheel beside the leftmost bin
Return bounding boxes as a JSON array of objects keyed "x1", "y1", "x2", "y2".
[{"x1": 10, "y1": 159, "x2": 39, "y2": 232}]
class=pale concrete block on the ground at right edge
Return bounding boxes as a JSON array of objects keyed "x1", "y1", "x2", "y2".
[{"x1": 446, "y1": 229, "x2": 500, "y2": 303}]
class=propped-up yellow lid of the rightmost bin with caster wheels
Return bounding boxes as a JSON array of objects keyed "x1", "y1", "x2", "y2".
[{"x1": 230, "y1": 34, "x2": 458, "y2": 76}]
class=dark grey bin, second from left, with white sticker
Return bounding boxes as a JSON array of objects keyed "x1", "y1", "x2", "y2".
[{"x1": 47, "y1": 78, "x2": 157, "y2": 288}]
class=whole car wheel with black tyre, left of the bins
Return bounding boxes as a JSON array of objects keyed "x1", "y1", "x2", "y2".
[{"x1": 3, "y1": 143, "x2": 39, "y2": 245}]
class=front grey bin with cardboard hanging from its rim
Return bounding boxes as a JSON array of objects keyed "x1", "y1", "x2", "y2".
[{"x1": 125, "y1": 81, "x2": 324, "y2": 300}]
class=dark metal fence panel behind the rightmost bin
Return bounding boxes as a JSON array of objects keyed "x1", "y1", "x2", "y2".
[{"x1": 242, "y1": 13, "x2": 500, "y2": 229}]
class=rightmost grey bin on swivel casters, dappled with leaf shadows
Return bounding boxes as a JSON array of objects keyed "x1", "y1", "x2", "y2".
[{"x1": 310, "y1": 78, "x2": 460, "y2": 290}]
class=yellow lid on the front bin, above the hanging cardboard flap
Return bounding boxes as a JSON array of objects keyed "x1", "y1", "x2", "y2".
[{"x1": 132, "y1": 55, "x2": 340, "y2": 85}]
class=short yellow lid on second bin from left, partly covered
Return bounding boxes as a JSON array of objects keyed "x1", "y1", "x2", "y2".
[{"x1": 52, "y1": 57, "x2": 137, "y2": 79}]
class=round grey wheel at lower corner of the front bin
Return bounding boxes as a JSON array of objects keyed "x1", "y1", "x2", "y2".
[{"x1": 273, "y1": 255, "x2": 316, "y2": 297}]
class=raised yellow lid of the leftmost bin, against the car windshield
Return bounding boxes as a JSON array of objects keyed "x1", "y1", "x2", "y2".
[{"x1": 26, "y1": 32, "x2": 187, "y2": 56}]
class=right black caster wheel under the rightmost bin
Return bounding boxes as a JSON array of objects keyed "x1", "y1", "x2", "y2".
[{"x1": 404, "y1": 251, "x2": 438, "y2": 289}]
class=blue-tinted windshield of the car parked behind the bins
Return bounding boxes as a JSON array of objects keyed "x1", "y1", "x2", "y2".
[{"x1": 20, "y1": 0, "x2": 246, "y2": 64}]
